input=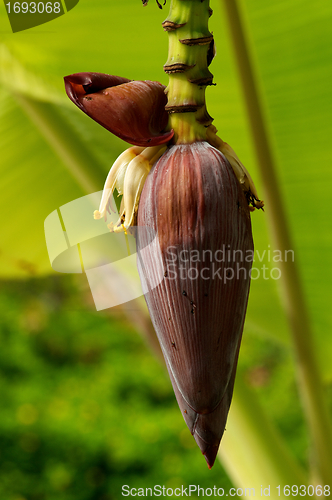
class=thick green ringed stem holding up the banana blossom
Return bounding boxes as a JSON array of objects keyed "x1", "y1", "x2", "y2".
[{"x1": 163, "y1": 0, "x2": 214, "y2": 144}]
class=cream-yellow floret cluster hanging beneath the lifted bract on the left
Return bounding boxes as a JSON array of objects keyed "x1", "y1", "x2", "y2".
[{"x1": 93, "y1": 146, "x2": 166, "y2": 233}]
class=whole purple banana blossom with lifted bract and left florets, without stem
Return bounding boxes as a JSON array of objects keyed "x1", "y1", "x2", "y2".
[{"x1": 65, "y1": 73, "x2": 253, "y2": 468}]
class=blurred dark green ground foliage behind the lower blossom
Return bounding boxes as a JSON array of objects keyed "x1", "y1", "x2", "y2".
[{"x1": 0, "y1": 276, "x2": 316, "y2": 500}]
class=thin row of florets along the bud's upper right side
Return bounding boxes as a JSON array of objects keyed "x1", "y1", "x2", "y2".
[{"x1": 206, "y1": 125, "x2": 264, "y2": 208}]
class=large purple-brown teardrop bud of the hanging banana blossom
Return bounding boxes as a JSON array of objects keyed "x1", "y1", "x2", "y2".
[{"x1": 137, "y1": 142, "x2": 253, "y2": 467}]
